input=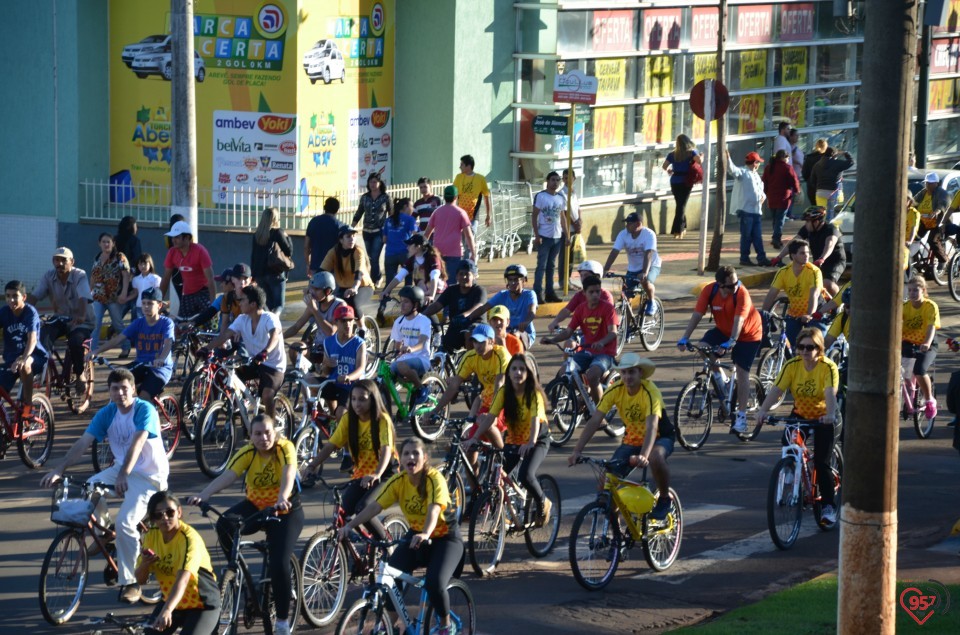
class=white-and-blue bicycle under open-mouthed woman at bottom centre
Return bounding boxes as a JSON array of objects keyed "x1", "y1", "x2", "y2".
[{"x1": 336, "y1": 537, "x2": 477, "y2": 635}]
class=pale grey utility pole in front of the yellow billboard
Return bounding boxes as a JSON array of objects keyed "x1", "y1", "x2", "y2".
[{"x1": 170, "y1": 0, "x2": 198, "y2": 235}]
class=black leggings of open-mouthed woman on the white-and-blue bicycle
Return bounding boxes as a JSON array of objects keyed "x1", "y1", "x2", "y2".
[{"x1": 390, "y1": 525, "x2": 463, "y2": 618}]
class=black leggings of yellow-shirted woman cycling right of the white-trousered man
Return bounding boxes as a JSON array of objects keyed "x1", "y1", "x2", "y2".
[{"x1": 217, "y1": 500, "x2": 303, "y2": 620}]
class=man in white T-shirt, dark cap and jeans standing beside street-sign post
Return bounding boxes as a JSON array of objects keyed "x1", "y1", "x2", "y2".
[{"x1": 530, "y1": 172, "x2": 567, "y2": 304}]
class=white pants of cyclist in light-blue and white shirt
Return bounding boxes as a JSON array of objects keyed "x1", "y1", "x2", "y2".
[{"x1": 87, "y1": 463, "x2": 167, "y2": 585}]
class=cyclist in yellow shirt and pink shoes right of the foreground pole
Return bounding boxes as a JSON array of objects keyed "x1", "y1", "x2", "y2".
[{"x1": 900, "y1": 276, "x2": 940, "y2": 419}]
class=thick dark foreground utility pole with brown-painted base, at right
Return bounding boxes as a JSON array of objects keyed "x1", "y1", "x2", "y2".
[{"x1": 837, "y1": 0, "x2": 917, "y2": 635}]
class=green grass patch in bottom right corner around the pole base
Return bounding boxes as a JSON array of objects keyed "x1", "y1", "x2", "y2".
[{"x1": 671, "y1": 576, "x2": 960, "y2": 635}]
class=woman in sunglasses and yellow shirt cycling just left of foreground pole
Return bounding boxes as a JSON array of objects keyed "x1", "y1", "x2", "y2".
[{"x1": 757, "y1": 327, "x2": 840, "y2": 524}]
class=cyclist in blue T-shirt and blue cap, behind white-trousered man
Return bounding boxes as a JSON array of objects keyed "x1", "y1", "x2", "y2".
[{"x1": 88, "y1": 287, "x2": 174, "y2": 401}]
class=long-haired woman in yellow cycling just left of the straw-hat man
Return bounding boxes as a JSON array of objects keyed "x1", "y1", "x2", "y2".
[{"x1": 464, "y1": 353, "x2": 553, "y2": 527}]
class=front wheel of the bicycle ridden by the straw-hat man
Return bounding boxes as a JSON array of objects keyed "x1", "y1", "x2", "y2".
[{"x1": 568, "y1": 501, "x2": 621, "y2": 591}]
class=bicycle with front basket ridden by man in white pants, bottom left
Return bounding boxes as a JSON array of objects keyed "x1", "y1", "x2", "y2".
[{"x1": 39, "y1": 477, "x2": 162, "y2": 626}]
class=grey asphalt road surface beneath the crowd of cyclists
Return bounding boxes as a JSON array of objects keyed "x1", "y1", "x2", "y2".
[{"x1": 0, "y1": 288, "x2": 960, "y2": 635}]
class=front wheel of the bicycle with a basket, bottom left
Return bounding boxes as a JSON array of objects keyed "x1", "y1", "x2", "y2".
[{"x1": 40, "y1": 529, "x2": 87, "y2": 626}]
